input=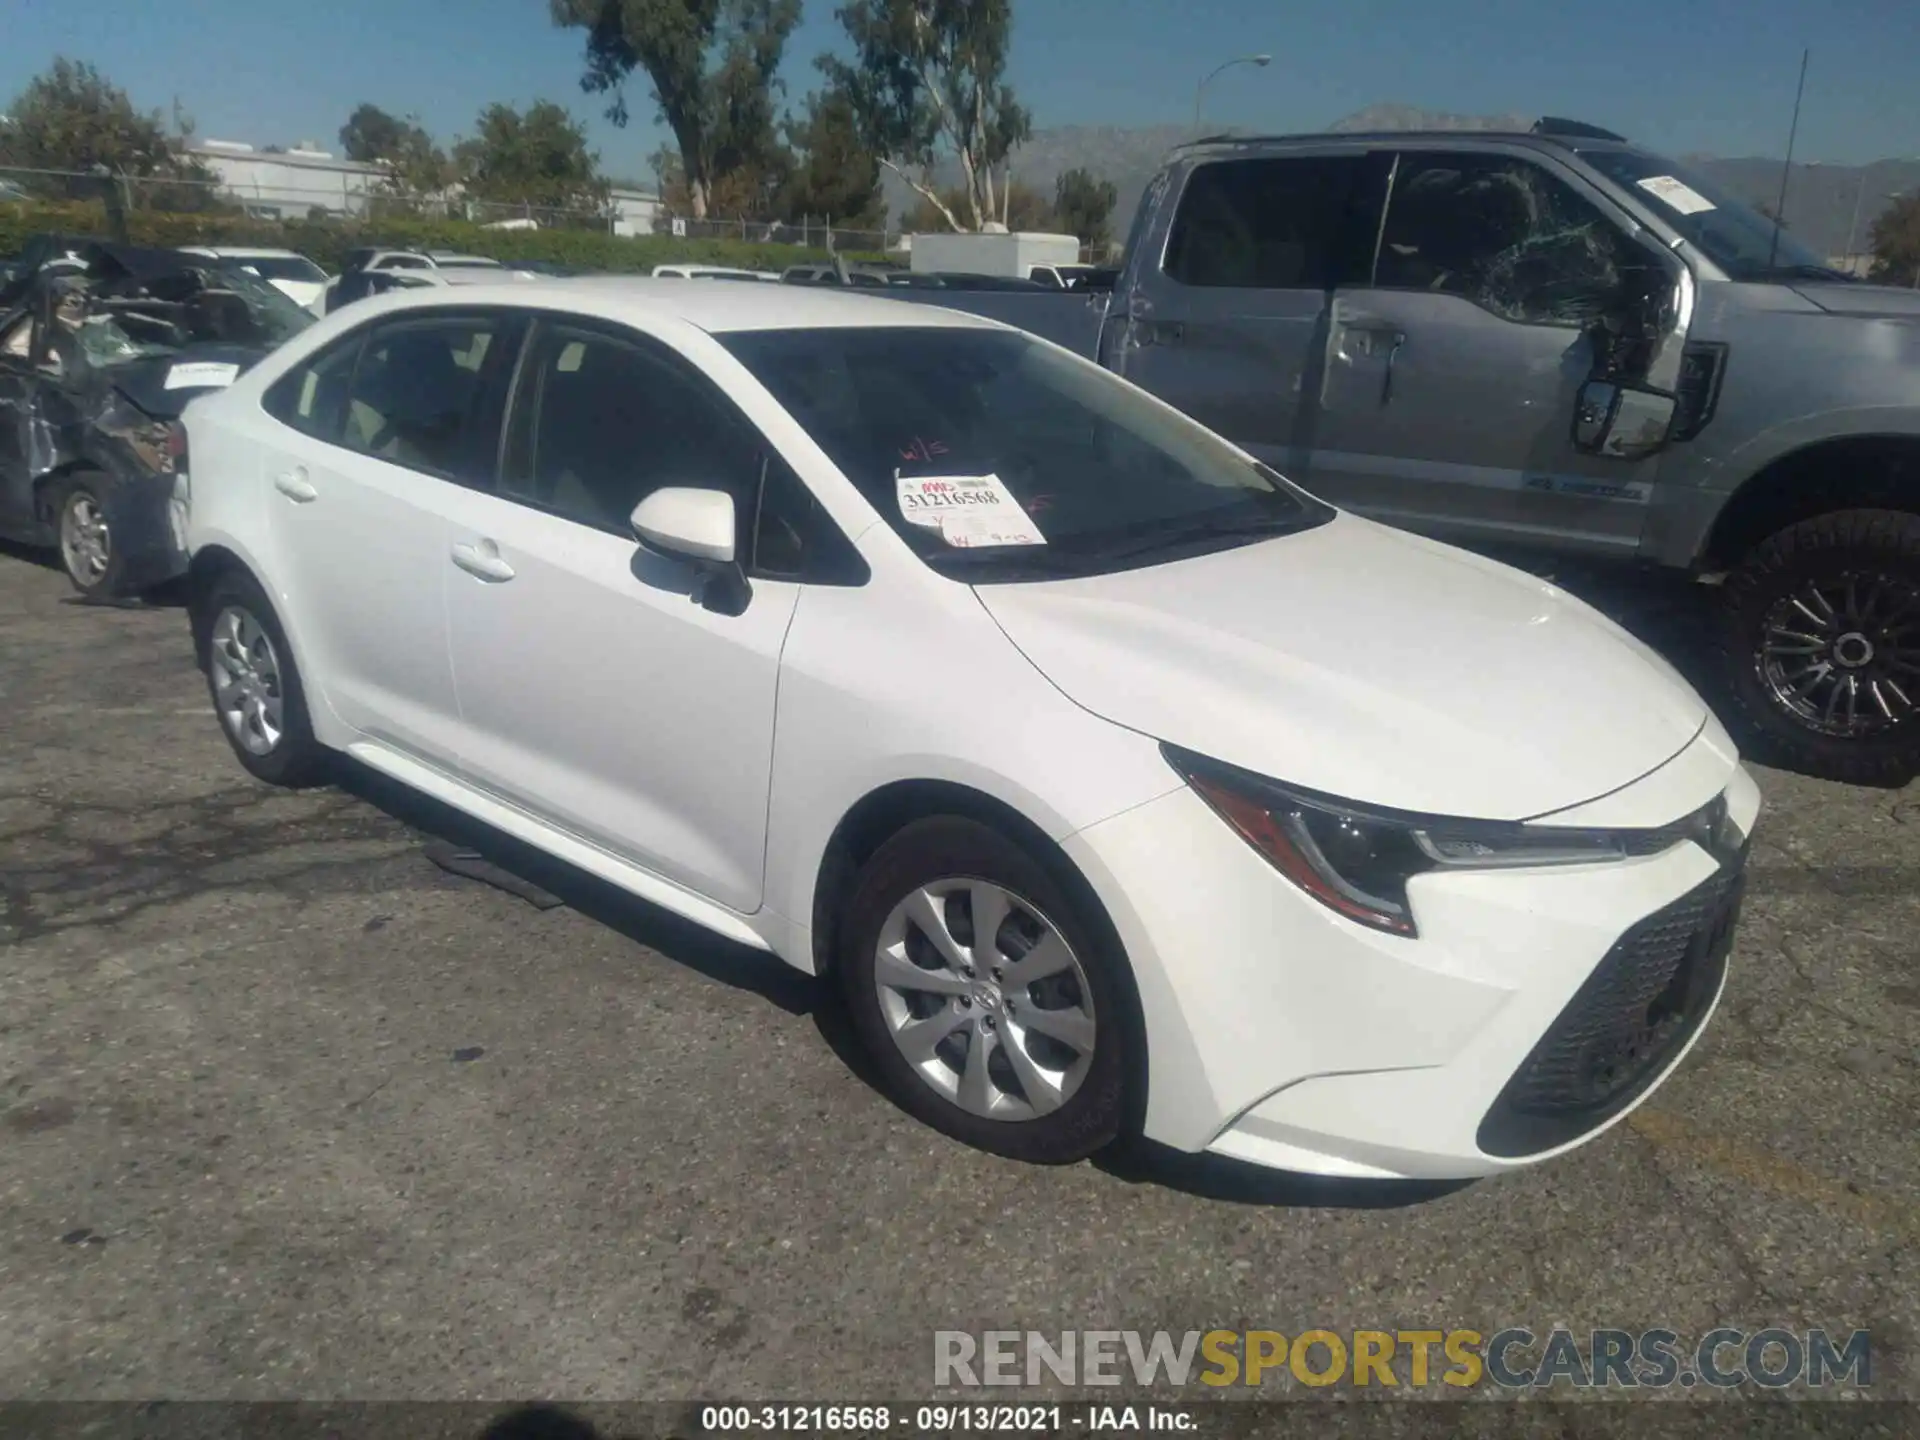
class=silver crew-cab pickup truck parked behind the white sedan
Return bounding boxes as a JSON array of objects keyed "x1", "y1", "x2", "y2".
[{"x1": 897, "y1": 121, "x2": 1920, "y2": 783}]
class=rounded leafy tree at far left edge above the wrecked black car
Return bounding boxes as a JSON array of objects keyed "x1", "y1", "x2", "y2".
[{"x1": 0, "y1": 58, "x2": 215, "y2": 209}]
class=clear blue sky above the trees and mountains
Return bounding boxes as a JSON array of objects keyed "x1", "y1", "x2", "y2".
[{"x1": 0, "y1": 0, "x2": 1920, "y2": 177}]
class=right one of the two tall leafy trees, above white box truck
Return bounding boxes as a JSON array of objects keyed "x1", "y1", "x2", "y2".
[{"x1": 820, "y1": 0, "x2": 1033, "y2": 230}]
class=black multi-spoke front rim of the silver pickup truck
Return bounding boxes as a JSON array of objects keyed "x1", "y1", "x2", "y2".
[{"x1": 1757, "y1": 570, "x2": 1920, "y2": 739}]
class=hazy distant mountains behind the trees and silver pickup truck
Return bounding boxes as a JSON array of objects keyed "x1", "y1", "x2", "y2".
[{"x1": 887, "y1": 104, "x2": 1920, "y2": 255}]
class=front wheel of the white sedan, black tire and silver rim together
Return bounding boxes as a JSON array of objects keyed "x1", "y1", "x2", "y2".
[{"x1": 835, "y1": 816, "x2": 1144, "y2": 1165}]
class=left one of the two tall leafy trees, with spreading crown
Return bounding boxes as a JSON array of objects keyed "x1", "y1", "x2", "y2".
[{"x1": 547, "y1": 0, "x2": 801, "y2": 219}]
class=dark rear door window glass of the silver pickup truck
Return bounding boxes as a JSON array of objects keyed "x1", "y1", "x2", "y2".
[{"x1": 1164, "y1": 156, "x2": 1371, "y2": 290}]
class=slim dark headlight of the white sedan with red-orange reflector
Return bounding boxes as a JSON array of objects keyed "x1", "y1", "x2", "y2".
[{"x1": 1160, "y1": 745, "x2": 1674, "y2": 935}]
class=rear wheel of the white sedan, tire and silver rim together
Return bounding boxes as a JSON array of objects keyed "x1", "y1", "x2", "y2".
[{"x1": 192, "y1": 570, "x2": 328, "y2": 789}]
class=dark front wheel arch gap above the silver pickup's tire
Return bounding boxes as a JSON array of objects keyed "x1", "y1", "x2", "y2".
[{"x1": 1701, "y1": 434, "x2": 1920, "y2": 570}]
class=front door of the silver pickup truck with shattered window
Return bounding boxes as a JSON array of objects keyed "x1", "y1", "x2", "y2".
[{"x1": 1306, "y1": 148, "x2": 1659, "y2": 553}]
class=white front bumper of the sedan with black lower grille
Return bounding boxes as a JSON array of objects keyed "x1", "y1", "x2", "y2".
[{"x1": 1066, "y1": 728, "x2": 1759, "y2": 1179}]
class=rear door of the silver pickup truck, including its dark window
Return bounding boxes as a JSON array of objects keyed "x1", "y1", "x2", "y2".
[{"x1": 1106, "y1": 150, "x2": 1377, "y2": 478}]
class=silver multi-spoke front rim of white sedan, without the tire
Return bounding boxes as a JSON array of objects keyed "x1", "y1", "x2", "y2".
[{"x1": 874, "y1": 879, "x2": 1096, "y2": 1121}]
